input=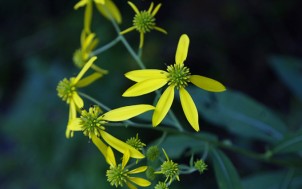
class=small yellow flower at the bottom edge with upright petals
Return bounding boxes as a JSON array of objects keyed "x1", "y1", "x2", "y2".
[{"x1": 106, "y1": 147, "x2": 151, "y2": 189}]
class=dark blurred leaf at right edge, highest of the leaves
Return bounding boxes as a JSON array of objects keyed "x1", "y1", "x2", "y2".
[{"x1": 269, "y1": 56, "x2": 302, "y2": 101}]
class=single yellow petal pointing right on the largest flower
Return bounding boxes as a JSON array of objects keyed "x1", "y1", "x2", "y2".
[{"x1": 190, "y1": 75, "x2": 226, "y2": 92}]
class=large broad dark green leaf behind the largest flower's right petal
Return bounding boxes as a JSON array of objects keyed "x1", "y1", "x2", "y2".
[{"x1": 189, "y1": 88, "x2": 287, "y2": 142}]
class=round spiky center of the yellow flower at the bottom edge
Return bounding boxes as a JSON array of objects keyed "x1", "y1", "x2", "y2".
[{"x1": 106, "y1": 164, "x2": 128, "y2": 187}]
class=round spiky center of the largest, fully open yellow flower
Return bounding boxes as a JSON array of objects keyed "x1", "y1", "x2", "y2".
[{"x1": 167, "y1": 64, "x2": 191, "y2": 89}]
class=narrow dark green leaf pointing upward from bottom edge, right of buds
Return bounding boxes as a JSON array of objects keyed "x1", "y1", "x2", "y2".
[{"x1": 210, "y1": 148, "x2": 242, "y2": 189}]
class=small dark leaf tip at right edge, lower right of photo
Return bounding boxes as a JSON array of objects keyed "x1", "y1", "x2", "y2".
[{"x1": 272, "y1": 130, "x2": 302, "y2": 154}]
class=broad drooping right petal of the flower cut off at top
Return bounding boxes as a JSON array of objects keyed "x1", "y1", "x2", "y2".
[{"x1": 96, "y1": 0, "x2": 122, "y2": 24}]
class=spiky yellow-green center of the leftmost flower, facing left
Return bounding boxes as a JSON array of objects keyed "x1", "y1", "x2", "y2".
[{"x1": 57, "y1": 78, "x2": 76, "y2": 103}]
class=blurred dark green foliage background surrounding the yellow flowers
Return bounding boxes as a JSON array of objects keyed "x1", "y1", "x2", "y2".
[{"x1": 0, "y1": 0, "x2": 302, "y2": 189}]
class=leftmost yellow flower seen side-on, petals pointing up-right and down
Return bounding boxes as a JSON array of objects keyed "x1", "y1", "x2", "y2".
[{"x1": 57, "y1": 57, "x2": 102, "y2": 138}]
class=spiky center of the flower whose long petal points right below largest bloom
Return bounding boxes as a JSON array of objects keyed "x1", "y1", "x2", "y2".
[{"x1": 80, "y1": 106, "x2": 107, "y2": 138}]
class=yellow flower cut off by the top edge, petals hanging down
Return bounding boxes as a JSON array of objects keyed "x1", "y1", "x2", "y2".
[{"x1": 74, "y1": 0, "x2": 122, "y2": 33}]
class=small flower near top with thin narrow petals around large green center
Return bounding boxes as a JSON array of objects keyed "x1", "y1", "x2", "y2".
[{"x1": 121, "y1": 1, "x2": 167, "y2": 48}]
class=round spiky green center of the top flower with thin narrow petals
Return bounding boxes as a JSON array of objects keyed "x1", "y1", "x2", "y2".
[{"x1": 133, "y1": 11, "x2": 156, "y2": 33}]
